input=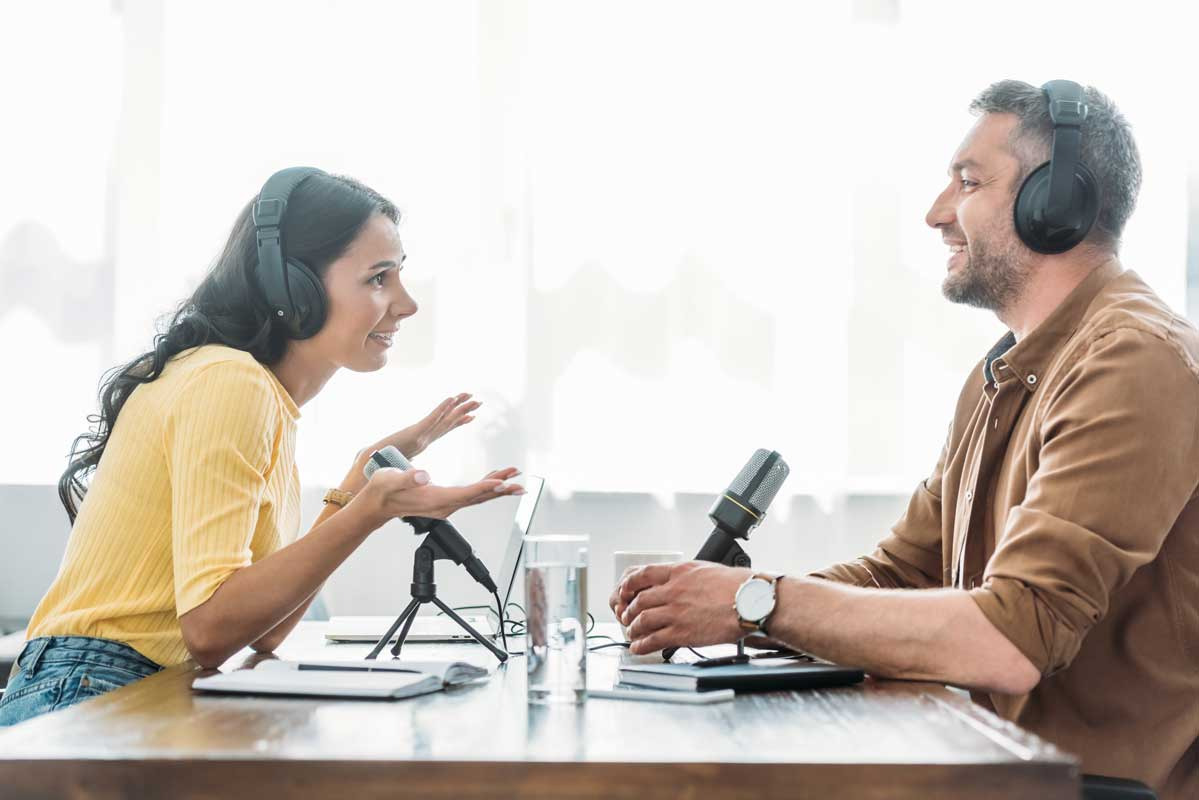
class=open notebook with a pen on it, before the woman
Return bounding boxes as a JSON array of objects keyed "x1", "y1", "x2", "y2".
[{"x1": 192, "y1": 661, "x2": 489, "y2": 699}]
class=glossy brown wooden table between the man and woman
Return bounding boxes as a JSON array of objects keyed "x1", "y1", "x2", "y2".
[{"x1": 0, "y1": 622, "x2": 1079, "y2": 800}]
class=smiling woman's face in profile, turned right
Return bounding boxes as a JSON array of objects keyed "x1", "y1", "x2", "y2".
[{"x1": 309, "y1": 213, "x2": 417, "y2": 372}]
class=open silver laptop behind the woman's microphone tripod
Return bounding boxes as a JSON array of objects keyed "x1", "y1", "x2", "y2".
[{"x1": 325, "y1": 475, "x2": 546, "y2": 643}]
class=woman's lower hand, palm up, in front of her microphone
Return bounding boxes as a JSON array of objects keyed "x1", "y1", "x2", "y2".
[{"x1": 351, "y1": 467, "x2": 524, "y2": 525}]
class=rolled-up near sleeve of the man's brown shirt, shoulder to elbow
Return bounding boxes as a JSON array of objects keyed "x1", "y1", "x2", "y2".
[{"x1": 970, "y1": 329, "x2": 1199, "y2": 675}]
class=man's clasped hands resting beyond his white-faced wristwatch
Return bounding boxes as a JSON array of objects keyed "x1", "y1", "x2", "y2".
[{"x1": 609, "y1": 561, "x2": 751, "y2": 655}]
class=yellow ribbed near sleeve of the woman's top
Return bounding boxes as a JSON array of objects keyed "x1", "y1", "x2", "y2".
[{"x1": 163, "y1": 361, "x2": 278, "y2": 616}]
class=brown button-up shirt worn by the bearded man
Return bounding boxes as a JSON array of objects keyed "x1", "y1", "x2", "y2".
[{"x1": 818, "y1": 259, "x2": 1199, "y2": 800}]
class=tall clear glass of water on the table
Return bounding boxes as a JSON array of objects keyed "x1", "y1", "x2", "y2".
[{"x1": 524, "y1": 534, "x2": 588, "y2": 704}]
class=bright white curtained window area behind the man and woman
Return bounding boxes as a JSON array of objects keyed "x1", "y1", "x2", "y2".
[{"x1": 0, "y1": 0, "x2": 1197, "y2": 618}]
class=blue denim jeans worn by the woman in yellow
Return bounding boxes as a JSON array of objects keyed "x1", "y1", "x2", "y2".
[{"x1": 0, "y1": 636, "x2": 162, "y2": 727}]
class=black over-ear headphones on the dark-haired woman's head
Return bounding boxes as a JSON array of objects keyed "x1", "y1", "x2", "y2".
[{"x1": 254, "y1": 167, "x2": 329, "y2": 339}]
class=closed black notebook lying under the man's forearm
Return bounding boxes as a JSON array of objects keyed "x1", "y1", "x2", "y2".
[{"x1": 620, "y1": 658, "x2": 866, "y2": 692}]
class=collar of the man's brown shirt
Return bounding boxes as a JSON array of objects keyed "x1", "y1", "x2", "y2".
[{"x1": 983, "y1": 258, "x2": 1123, "y2": 392}]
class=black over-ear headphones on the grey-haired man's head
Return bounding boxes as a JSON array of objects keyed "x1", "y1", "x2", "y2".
[{"x1": 1014, "y1": 80, "x2": 1099, "y2": 253}]
